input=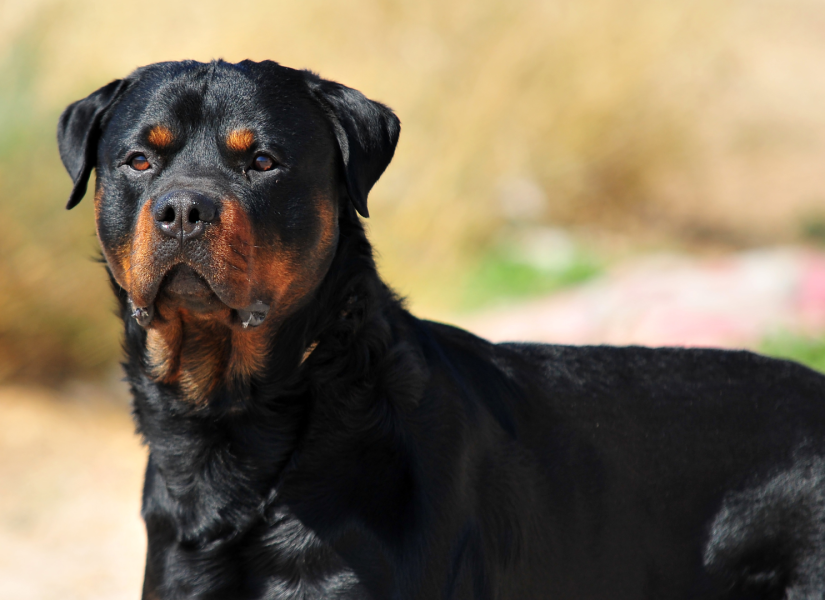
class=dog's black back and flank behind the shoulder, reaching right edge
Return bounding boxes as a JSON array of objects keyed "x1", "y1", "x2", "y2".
[{"x1": 422, "y1": 326, "x2": 825, "y2": 598}]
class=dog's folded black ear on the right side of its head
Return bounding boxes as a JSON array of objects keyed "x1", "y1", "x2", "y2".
[{"x1": 306, "y1": 72, "x2": 401, "y2": 217}]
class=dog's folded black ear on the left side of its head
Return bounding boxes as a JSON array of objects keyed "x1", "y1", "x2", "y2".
[{"x1": 57, "y1": 79, "x2": 128, "y2": 209}]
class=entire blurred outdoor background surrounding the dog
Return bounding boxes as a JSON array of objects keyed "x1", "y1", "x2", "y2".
[{"x1": 0, "y1": 0, "x2": 825, "y2": 600}]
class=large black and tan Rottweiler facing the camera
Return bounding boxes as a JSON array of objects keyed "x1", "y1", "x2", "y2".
[{"x1": 58, "y1": 62, "x2": 825, "y2": 600}]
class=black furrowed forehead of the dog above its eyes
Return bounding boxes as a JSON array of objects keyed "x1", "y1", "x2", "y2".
[{"x1": 106, "y1": 63, "x2": 328, "y2": 150}]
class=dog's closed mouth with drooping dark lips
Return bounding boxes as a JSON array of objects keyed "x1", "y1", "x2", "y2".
[{"x1": 132, "y1": 264, "x2": 269, "y2": 329}]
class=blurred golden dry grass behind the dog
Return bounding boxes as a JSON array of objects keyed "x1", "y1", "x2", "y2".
[{"x1": 0, "y1": 0, "x2": 825, "y2": 379}]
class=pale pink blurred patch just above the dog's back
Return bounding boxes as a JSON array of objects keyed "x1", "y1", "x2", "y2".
[{"x1": 454, "y1": 249, "x2": 825, "y2": 348}]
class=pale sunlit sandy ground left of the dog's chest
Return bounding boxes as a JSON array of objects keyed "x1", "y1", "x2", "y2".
[{"x1": 0, "y1": 386, "x2": 145, "y2": 600}]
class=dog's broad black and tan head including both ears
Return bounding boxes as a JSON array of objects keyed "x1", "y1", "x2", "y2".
[{"x1": 58, "y1": 61, "x2": 399, "y2": 329}]
